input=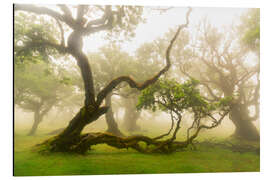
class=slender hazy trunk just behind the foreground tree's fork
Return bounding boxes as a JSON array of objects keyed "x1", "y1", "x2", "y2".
[{"x1": 105, "y1": 93, "x2": 123, "y2": 136}]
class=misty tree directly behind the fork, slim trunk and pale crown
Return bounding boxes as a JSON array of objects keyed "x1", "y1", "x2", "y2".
[{"x1": 88, "y1": 43, "x2": 136, "y2": 136}]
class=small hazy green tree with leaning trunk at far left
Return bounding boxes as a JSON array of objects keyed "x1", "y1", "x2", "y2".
[{"x1": 14, "y1": 61, "x2": 75, "y2": 135}]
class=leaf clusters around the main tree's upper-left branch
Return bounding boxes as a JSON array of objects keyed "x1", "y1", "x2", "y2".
[{"x1": 14, "y1": 12, "x2": 60, "y2": 63}]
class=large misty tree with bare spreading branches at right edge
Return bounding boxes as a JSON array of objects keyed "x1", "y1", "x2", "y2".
[{"x1": 179, "y1": 20, "x2": 260, "y2": 140}]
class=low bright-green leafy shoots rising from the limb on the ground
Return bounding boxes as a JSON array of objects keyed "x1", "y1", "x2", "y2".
[{"x1": 137, "y1": 79, "x2": 232, "y2": 144}]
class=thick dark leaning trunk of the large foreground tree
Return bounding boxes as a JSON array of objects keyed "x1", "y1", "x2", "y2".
[{"x1": 40, "y1": 30, "x2": 108, "y2": 152}]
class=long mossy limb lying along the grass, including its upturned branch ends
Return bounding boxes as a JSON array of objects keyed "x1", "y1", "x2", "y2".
[{"x1": 37, "y1": 107, "x2": 229, "y2": 154}]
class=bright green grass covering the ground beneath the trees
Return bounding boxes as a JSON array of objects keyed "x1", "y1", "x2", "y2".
[{"x1": 14, "y1": 133, "x2": 260, "y2": 176}]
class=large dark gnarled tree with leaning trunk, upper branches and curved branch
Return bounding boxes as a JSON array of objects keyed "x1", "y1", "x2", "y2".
[{"x1": 15, "y1": 4, "x2": 191, "y2": 152}]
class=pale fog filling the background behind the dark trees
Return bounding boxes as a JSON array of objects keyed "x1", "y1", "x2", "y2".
[{"x1": 14, "y1": 6, "x2": 260, "y2": 148}]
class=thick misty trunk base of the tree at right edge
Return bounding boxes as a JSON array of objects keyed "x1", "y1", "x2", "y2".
[{"x1": 230, "y1": 105, "x2": 260, "y2": 141}]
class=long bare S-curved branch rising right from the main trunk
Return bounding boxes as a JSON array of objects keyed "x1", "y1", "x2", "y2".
[{"x1": 97, "y1": 8, "x2": 192, "y2": 105}]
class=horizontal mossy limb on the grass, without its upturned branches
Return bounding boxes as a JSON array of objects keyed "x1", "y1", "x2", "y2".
[{"x1": 37, "y1": 132, "x2": 192, "y2": 154}]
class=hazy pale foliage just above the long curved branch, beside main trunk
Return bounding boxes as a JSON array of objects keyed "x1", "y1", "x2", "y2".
[{"x1": 88, "y1": 43, "x2": 165, "y2": 91}]
